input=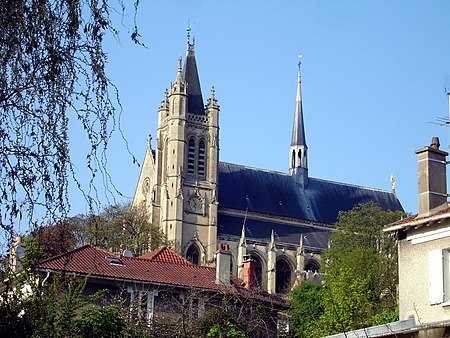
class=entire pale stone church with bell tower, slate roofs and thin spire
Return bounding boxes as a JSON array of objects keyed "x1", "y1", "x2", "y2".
[{"x1": 133, "y1": 32, "x2": 403, "y2": 294}]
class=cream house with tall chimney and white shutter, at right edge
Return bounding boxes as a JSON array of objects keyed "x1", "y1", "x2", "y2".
[{"x1": 324, "y1": 137, "x2": 450, "y2": 338}]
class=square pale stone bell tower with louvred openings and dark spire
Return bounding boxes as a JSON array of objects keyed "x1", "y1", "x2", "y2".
[{"x1": 133, "y1": 29, "x2": 219, "y2": 264}]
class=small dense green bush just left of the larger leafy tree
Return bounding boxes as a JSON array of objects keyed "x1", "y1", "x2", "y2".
[{"x1": 289, "y1": 282, "x2": 324, "y2": 338}]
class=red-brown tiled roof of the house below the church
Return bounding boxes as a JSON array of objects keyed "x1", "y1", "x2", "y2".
[{"x1": 37, "y1": 245, "x2": 287, "y2": 307}]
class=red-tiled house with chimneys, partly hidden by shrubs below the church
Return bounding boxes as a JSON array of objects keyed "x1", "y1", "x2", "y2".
[{"x1": 37, "y1": 244, "x2": 288, "y2": 337}]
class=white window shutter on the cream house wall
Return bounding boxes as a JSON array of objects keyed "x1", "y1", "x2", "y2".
[{"x1": 428, "y1": 249, "x2": 444, "y2": 305}]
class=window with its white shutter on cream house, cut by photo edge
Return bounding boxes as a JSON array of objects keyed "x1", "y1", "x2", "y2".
[{"x1": 428, "y1": 249, "x2": 450, "y2": 305}]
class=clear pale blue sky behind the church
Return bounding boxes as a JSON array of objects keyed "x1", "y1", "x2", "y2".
[{"x1": 67, "y1": 0, "x2": 450, "y2": 214}]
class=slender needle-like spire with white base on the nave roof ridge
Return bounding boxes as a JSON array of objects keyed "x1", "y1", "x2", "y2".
[{"x1": 289, "y1": 55, "x2": 308, "y2": 184}]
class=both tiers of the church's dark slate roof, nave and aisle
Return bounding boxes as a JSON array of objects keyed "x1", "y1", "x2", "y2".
[{"x1": 218, "y1": 162, "x2": 403, "y2": 248}]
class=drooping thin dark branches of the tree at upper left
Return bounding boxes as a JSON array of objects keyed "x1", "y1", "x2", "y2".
[{"x1": 0, "y1": 0, "x2": 139, "y2": 252}]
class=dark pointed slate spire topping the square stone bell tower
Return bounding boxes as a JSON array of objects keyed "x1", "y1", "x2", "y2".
[{"x1": 182, "y1": 27, "x2": 205, "y2": 115}]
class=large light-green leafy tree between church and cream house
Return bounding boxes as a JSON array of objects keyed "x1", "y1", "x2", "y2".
[{"x1": 312, "y1": 202, "x2": 403, "y2": 335}]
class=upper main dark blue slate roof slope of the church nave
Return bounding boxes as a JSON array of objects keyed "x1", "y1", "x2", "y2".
[{"x1": 219, "y1": 162, "x2": 403, "y2": 224}]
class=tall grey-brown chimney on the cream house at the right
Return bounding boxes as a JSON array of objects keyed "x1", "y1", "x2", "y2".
[{"x1": 416, "y1": 137, "x2": 448, "y2": 217}]
